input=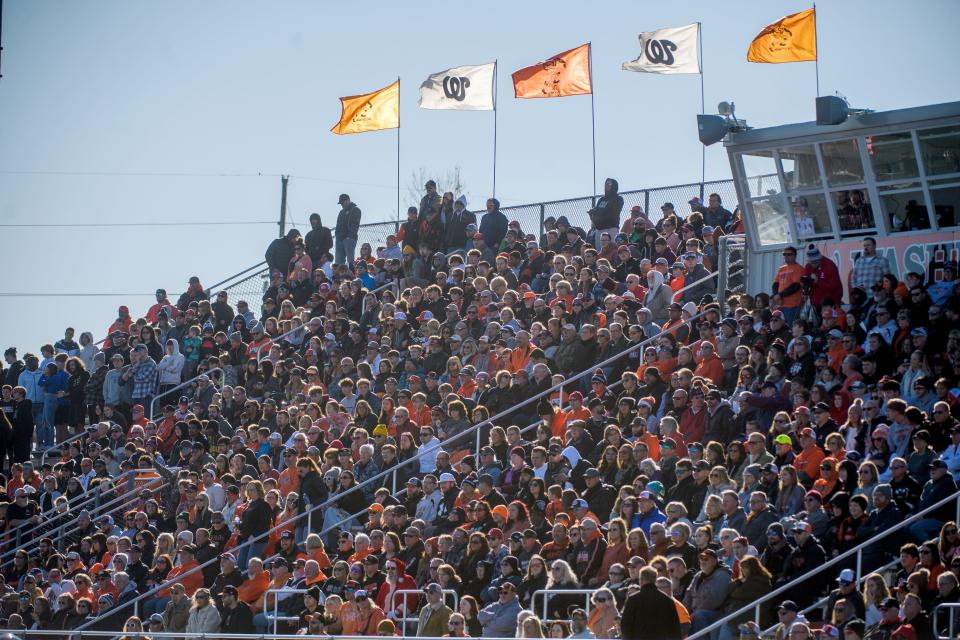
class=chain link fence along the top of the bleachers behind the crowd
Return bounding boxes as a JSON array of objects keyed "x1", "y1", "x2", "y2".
[{"x1": 222, "y1": 176, "x2": 744, "y2": 308}]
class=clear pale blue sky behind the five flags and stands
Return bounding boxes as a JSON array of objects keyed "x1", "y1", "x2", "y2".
[{"x1": 0, "y1": 0, "x2": 960, "y2": 354}]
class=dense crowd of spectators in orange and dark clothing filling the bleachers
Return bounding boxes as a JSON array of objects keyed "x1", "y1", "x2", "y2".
[{"x1": 0, "y1": 179, "x2": 960, "y2": 640}]
